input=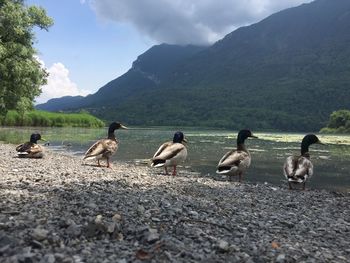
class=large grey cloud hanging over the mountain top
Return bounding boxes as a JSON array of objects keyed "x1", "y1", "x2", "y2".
[{"x1": 89, "y1": 0, "x2": 311, "y2": 44}]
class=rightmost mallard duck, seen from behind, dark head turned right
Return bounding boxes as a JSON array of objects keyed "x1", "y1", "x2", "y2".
[{"x1": 283, "y1": 134, "x2": 322, "y2": 190}]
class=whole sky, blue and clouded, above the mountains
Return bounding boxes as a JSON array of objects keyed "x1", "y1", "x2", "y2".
[{"x1": 25, "y1": 0, "x2": 311, "y2": 104}]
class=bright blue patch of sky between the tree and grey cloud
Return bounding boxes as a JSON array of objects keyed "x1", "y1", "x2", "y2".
[{"x1": 27, "y1": 0, "x2": 154, "y2": 102}]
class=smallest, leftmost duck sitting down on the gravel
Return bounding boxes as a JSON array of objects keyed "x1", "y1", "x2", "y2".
[{"x1": 16, "y1": 133, "x2": 45, "y2": 158}]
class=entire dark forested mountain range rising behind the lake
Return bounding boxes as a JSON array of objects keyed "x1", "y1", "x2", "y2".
[{"x1": 37, "y1": 0, "x2": 350, "y2": 131}]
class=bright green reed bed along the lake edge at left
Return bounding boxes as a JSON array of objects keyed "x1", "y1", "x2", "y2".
[{"x1": 2, "y1": 110, "x2": 105, "y2": 128}]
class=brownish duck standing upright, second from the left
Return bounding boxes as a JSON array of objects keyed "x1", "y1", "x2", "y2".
[{"x1": 83, "y1": 122, "x2": 127, "y2": 168}]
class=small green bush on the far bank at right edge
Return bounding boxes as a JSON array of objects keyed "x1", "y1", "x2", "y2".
[{"x1": 320, "y1": 110, "x2": 350, "y2": 133}]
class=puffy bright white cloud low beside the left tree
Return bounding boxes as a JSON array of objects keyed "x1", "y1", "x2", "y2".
[{"x1": 36, "y1": 58, "x2": 88, "y2": 104}]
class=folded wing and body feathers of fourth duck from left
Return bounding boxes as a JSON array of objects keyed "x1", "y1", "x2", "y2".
[{"x1": 218, "y1": 150, "x2": 250, "y2": 172}]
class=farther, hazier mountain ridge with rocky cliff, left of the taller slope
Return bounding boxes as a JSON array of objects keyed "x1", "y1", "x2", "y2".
[{"x1": 36, "y1": 44, "x2": 204, "y2": 116}]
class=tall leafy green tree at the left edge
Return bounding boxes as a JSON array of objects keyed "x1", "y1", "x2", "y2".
[{"x1": 0, "y1": 0, "x2": 53, "y2": 116}]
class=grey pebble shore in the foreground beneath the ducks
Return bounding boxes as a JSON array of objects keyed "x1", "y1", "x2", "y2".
[{"x1": 0, "y1": 144, "x2": 350, "y2": 263}]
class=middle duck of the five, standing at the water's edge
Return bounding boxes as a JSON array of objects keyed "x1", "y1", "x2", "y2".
[{"x1": 151, "y1": 131, "x2": 187, "y2": 176}]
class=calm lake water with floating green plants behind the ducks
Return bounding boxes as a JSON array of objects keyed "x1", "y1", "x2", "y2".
[{"x1": 0, "y1": 127, "x2": 350, "y2": 192}]
